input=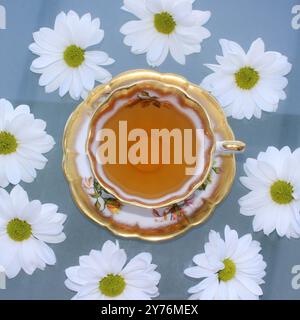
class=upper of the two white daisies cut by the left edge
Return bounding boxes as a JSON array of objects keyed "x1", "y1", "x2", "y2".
[{"x1": 0, "y1": 99, "x2": 55, "y2": 188}]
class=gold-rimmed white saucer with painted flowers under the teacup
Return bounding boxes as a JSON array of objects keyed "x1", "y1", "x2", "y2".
[{"x1": 63, "y1": 70, "x2": 235, "y2": 241}]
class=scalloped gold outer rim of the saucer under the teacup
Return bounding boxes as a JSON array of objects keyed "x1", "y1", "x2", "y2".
[{"x1": 62, "y1": 70, "x2": 236, "y2": 241}]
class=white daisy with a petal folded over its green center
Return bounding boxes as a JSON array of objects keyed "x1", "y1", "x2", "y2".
[{"x1": 184, "y1": 226, "x2": 266, "y2": 300}]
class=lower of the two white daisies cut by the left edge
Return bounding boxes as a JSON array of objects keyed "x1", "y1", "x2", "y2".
[{"x1": 0, "y1": 185, "x2": 66, "y2": 278}]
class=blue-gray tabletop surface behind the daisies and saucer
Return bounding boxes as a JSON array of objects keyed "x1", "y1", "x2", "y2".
[{"x1": 0, "y1": 0, "x2": 300, "y2": 299}]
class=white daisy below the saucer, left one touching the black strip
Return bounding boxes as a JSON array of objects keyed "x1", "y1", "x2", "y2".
[{"x1": 65, "y1": 241, "x2": 160, "y2": 300}]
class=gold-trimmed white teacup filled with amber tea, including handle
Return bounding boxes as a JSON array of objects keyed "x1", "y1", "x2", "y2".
[{"x1": 86, "y1": 80, "x2": 245, "y2": 208}]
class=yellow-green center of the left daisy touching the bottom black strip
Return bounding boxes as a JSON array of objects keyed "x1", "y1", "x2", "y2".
[{"x1": 99, "y1": 273, "x2": 126, "y2": 298}]
